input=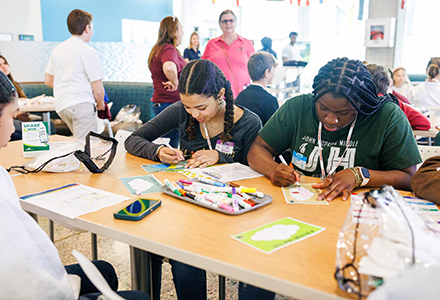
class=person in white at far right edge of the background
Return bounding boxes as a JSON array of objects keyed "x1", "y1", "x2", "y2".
[{"x1": 413, "y1": 57, "x2": 440, "y2": 107}]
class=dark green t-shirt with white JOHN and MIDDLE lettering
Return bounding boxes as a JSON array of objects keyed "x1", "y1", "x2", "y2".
[{"x1": 259, "y1": 94, "x2": 422, "y2": 177}]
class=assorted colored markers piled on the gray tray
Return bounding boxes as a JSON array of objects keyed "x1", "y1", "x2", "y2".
[{"x1": 162, "y1": 178, "x2": 272, "y2": 214}]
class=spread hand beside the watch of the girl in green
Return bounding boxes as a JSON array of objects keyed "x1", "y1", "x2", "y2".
[{"x1": 312, "y1": 169, "x2": 356, "y2": 201}]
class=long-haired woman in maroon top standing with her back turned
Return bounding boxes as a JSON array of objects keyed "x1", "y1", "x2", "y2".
[{"x1": 148, "y1": 17, "x2": 185, "y2": 148}]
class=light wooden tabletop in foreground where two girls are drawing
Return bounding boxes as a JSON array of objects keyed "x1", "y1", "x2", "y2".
[{"x1": 0, "y1": 136, "x2": 398, "y2": 299}]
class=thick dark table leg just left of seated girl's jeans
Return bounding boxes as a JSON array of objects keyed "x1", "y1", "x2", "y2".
[{"x1": 130, "y1": 246, "x2": 153, "y2": 297}]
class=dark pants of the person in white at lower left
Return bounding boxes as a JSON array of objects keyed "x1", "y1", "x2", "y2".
[{"x1": 65, "y1": 260, "x2": 150, "y2": 300}]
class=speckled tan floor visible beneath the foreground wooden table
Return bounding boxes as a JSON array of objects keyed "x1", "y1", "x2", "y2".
[{"x1": 38, "y1": 217, "x2": 293, "y2": 300}]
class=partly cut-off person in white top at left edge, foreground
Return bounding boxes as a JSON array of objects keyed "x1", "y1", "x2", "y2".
[{"x1": 0, "y1": 72, "x2": 150, "y2": 300}]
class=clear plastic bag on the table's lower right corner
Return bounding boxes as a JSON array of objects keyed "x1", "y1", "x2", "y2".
[{"x1": 335, "y1": 186, "x2": 440, "y2": 297}]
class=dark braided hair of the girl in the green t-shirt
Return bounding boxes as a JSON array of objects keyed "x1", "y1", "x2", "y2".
[{"x1": 313, "y1": 57, "x2": 387, "y2": 115}]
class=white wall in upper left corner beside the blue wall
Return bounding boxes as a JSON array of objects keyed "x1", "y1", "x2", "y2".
[{"x1": 0, "y1": 0, "x2": 43, "y2": 41}]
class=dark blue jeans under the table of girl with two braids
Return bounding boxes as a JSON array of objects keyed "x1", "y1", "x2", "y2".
[{"x1": 151, "y1": 253, "x2": 207, "y2": 300}]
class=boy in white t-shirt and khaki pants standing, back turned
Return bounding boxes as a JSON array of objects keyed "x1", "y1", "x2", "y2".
[{"x1": 45, "y1": 9, "x2": 105, "y2": 140}]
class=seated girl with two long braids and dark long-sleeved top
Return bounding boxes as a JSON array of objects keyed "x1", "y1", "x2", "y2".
[{"x1": 125, "y1": 59, "x2": 261, "y2": 300}]
